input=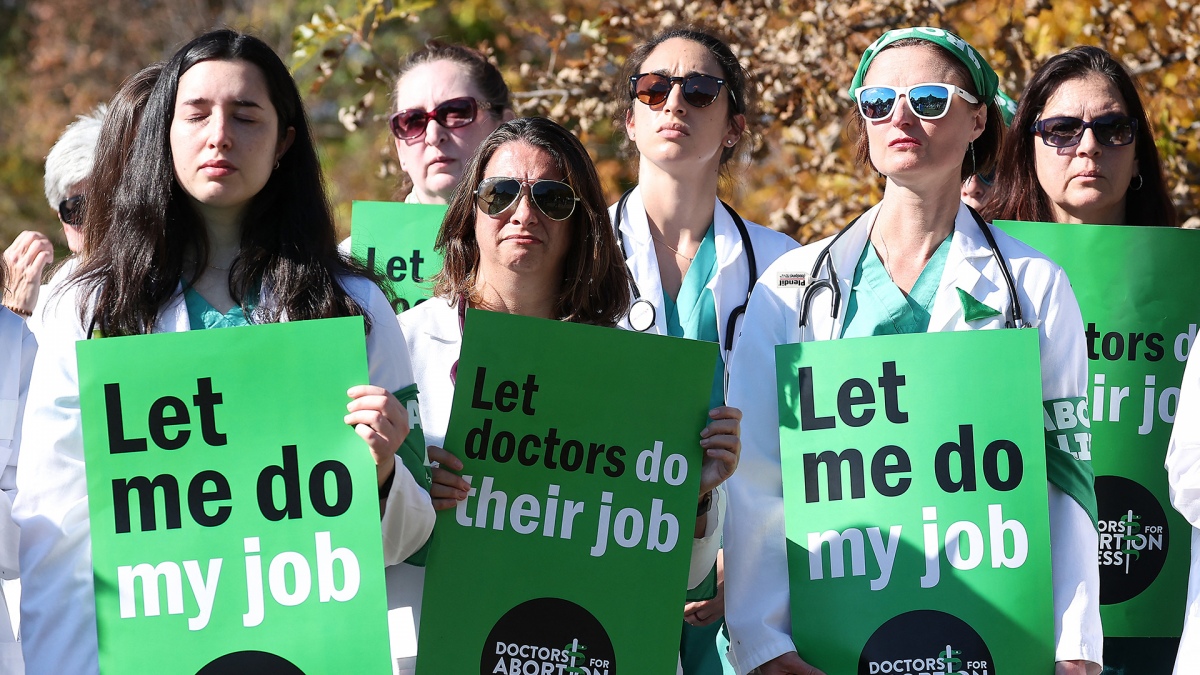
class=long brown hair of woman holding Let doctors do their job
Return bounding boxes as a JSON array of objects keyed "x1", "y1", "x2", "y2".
[{"x1": 433, "y1": 118, "x2": 630, "y2": 325}]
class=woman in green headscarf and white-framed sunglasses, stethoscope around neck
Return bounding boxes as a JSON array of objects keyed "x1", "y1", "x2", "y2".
[{"x1": 726, "y1": 28, "x2": 1103, "y2": 675}]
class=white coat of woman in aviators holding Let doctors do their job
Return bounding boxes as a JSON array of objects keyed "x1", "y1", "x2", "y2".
[{"x1": 400, "y1": 298, "x2": 727, "y2": 672}]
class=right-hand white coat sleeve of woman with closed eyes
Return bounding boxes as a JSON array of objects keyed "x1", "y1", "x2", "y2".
[{"x1": 352, "y1": 279, "x2": 434, "y2": 565}]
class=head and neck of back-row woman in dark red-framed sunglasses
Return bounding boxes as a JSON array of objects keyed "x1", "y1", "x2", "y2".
[{"x1": 388, "y1": 40, "x2": 512, "y2": 204}]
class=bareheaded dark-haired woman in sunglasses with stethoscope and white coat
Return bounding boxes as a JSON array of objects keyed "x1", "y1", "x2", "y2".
[{"x1": 611, "y1": 28, "x2": 798, "y2": 675}]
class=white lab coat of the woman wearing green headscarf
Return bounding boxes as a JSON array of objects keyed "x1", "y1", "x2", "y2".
[{"x1": 725, "y1": 200, "x2": 1103, "y2": 674}]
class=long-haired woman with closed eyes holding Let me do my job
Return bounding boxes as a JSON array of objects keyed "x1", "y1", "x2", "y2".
[{"x1": 14, "y1": 30, "x2": 433, "y2": 673}]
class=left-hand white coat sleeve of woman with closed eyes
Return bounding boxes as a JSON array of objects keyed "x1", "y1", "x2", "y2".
[{"x1": 13, "y1": 292, "x2": 100, "y2": 675}]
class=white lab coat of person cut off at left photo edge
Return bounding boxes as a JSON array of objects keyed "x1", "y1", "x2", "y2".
[{"x1": 0, "y1": 307, "x2": 37, "y2": 675}]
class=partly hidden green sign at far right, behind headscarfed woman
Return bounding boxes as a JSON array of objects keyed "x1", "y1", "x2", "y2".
[{"x1": 996, "y1": 221, "x2": 1200, "y2": 638}]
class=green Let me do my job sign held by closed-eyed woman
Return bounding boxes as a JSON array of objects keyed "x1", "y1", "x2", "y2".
[{"x1": 77, "y1": 317, "x2": 390, "y2": 675}]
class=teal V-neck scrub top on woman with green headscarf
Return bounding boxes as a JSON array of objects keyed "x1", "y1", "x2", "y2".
[{"x1": 841, "y1": 237, "x2": 952, "y2": 338}]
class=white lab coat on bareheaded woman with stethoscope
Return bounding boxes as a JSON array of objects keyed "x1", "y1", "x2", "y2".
[{"x1": 608, "y1": 187, "x2": 799, "y2": 364}]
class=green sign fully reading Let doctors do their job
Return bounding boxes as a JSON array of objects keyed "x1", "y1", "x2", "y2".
[{"x1": 416, "y1": 310, "x2": 716, "y2": 675}]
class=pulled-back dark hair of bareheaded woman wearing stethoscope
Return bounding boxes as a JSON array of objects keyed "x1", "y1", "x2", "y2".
[{"x1": 613, "y1": 26, "x2": 754, "y2": 174}]
